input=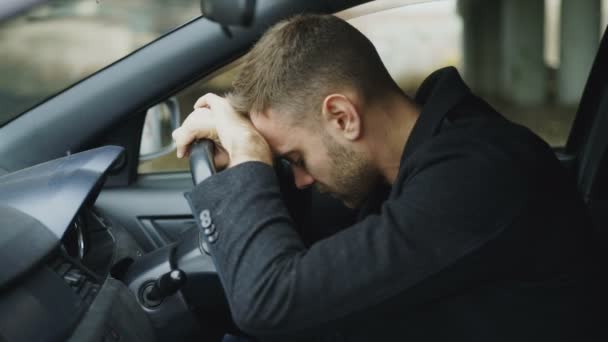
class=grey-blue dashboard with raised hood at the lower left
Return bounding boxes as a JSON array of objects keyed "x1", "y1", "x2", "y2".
[{"x1": 0, "y1": 146, "x2": 155, "y2": 341}]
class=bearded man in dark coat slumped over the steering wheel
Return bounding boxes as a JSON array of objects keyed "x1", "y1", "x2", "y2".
[{"x1": 174, "y1": 15, "x2": 600, "y2": 341}]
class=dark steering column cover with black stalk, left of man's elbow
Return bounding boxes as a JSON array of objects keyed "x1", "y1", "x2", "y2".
[{"x1": 121, "y1": 227, "x2": 230, "y2": 341}]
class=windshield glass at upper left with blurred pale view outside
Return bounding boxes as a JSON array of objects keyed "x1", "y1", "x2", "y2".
[{"x1": 0, "y1": 0, "x2": 200, "y2": 126}]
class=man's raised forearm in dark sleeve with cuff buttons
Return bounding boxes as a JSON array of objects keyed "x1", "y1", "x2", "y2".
[{"x1": 186, "y1": 163, "x2": 306, "y2": 332}]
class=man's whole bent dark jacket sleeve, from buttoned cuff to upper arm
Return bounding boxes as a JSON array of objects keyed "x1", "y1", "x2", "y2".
[{"x1": 188, "y1": 141, "x2": 523, "y2": 336}]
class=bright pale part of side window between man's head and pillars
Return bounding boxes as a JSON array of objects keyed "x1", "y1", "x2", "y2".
[{"x1": 341, "y1": 1, "x2": 462, "y2": 97}]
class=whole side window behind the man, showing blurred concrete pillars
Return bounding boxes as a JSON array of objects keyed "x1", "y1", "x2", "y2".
[{"x1": 339, "y1": 0, "x2": 608, "y2": 147}]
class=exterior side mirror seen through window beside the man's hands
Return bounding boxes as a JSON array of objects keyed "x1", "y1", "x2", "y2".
[{"x1": 139, "y1": 97, "x2": 180, "y2": 161}]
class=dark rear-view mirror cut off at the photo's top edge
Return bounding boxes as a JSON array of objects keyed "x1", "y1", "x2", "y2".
[{"x1": 201, "y1": 0, "x2": 255, "y2": 27}]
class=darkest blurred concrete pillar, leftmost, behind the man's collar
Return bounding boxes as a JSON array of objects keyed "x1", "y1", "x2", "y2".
[{"x1": 458, "y1": 0, "x2": 502, "y2": 96}]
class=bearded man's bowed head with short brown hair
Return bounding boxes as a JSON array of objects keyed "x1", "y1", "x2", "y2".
[{"x1": 230, "y1": 15, "x2": 414, "y2": 207}]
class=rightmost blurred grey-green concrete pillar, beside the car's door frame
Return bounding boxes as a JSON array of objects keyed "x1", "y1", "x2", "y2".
[{"x1": 557, "y1": 0, "x2": 601, "y2": 105}]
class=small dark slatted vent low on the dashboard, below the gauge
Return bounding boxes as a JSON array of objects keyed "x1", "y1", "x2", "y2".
[{"x1": 49, "y1": 254, "x2": 100, "y2": 305}]
